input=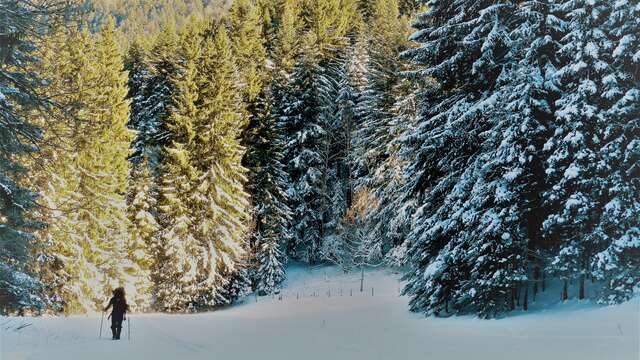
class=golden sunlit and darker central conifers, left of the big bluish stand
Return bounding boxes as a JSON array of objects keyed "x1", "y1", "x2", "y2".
[{"x1": 4, "y1": 0, "x2": 415, "y2": 313}]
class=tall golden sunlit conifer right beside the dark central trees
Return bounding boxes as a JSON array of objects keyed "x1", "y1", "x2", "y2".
[{"x1": 191, "y1": 26, "x2": 249, "y2": 304}]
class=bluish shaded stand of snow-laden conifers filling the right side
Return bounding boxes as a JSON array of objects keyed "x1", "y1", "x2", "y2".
[{"x1": 403, "y1": 0, "x2": 640, "y2": 317}]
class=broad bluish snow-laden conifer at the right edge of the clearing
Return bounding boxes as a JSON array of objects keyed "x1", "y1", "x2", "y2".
[{"x1": 403, "y1": 2, "x2": 554, "y2": 317}]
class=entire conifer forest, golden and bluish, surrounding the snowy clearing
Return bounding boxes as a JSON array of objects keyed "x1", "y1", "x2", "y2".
[{"x1": 0, "y1": 0, "x2": 640, "y2": 324}]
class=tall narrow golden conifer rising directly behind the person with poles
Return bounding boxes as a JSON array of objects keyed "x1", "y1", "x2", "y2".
[{"x1": 77, "y1": 21, "x2": 145, "y2": 306}]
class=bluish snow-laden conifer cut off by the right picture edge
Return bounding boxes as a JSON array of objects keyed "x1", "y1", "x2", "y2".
[{"x1": 592, "y1": 1, "x2": 640, "y2": 303}]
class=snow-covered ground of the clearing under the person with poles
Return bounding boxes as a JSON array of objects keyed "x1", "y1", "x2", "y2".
[{"x1": 0, "y1": 267, "x2": 640, "y2": 360}]
